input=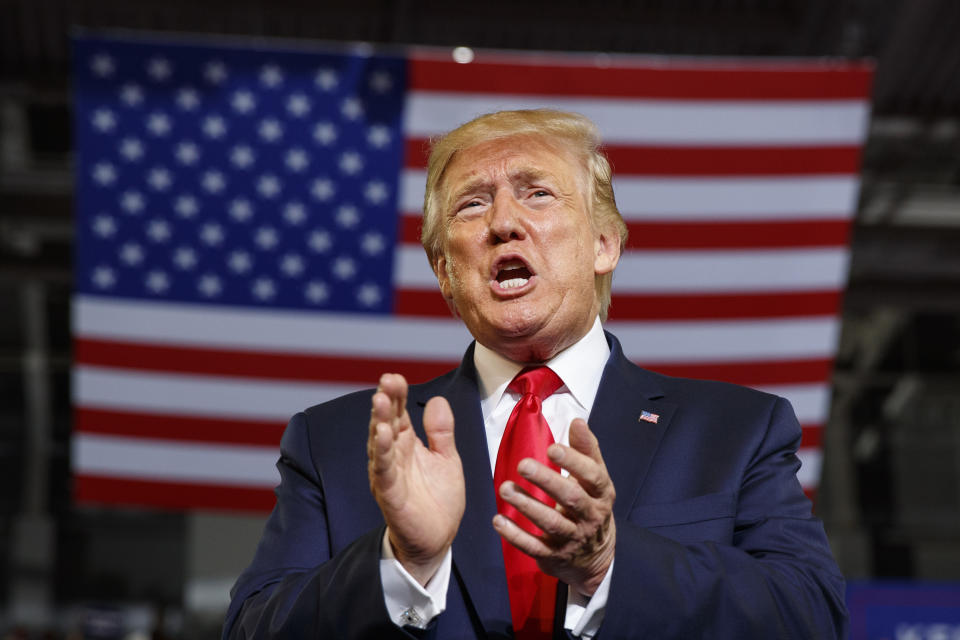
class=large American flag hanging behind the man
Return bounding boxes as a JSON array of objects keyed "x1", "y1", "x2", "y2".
[{"x1": 72, "y1": 36, "x2": 872, "y2": 511}]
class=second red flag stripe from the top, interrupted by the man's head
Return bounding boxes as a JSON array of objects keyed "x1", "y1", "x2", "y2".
[{"x1": 405, "y1": 138, "x2": 860, "y2": 176}]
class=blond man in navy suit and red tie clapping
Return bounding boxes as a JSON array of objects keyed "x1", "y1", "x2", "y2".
[{"x1": 224, "y1": 111, "x2": 846, "y2": 638}]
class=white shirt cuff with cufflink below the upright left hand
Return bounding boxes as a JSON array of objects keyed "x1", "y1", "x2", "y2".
[{"x1": 380, "y1": 531, "x2": 453, "y2": 629}]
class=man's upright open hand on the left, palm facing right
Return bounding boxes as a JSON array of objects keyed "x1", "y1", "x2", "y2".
[{"x1": 367, "y1": 373, "x2": 466, "y2": 585}]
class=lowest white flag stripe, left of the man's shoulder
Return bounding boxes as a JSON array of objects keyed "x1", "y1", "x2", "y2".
[{"x1": 72, "y1": 433, "x2": 280, "y2": 488}]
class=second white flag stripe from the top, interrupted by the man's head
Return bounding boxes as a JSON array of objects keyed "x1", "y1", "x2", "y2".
[{"x1": 400, "y1": 169, "x2": 860, "y2": 222}]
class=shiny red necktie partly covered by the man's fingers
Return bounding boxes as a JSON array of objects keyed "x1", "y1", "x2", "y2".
[{"x1": 493, "y1": 367, "x2": 563, "y2": 640}]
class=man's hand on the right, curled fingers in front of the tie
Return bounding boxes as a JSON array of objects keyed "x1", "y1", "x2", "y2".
[{"x1": 493, "y1": 418, "x2": 617, "y2": 596}]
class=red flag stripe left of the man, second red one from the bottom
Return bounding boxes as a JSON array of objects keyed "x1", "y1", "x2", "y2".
[{"x1": 73, "y1": 407, "x2": 286, "y2": 446}]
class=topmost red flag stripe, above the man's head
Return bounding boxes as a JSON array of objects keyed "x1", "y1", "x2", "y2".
[{"x1": 408, "y1": 58, "x2": 873, "y2": 100}]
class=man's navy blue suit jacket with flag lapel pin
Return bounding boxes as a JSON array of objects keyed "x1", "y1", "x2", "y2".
[{"x1": 224, "y1": 334, "x2": 846, "y2": 640}]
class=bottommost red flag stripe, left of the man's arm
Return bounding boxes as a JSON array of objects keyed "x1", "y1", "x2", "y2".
[{"x1": 73, "y1": 474, "x2": 276, "y2": 512}]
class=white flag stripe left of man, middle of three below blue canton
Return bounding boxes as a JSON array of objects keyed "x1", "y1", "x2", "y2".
[{"x1": 73, "y1": 365, "x2": 366, "y2": 420}]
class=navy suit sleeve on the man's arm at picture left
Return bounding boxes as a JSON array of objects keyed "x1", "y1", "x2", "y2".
[{"x1": 223, "y1": 414, "x2": 418, "y2": 640}]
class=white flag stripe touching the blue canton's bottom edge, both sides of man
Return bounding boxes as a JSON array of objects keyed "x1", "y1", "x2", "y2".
[{"x1": 73, "y1": 296, "x2": 838, "y2": 363}]
